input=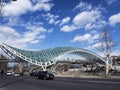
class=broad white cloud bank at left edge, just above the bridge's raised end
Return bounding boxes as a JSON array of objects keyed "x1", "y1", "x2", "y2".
[{"x1": 0, "y1": 15, "x2": 52, "y2": 48}]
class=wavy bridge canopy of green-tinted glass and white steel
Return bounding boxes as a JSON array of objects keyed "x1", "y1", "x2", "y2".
[{"x1": 1, "y1": 43, "x2": 105, "y2": 70}]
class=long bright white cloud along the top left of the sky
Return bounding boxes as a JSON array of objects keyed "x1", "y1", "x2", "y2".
[{"x1": 2, "y1": 0, "x2": 53, "y2": 16}]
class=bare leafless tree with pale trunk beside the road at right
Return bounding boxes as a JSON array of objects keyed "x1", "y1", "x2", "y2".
[{"x1": 97, "y1": 28, "x2": 117, "y2": 76}]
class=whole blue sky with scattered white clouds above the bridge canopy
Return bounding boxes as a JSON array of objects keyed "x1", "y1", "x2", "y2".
[{"x1": 0, "y1": 0, "x2": 120, "y2": 55}]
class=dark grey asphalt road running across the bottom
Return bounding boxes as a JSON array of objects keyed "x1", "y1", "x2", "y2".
[{"x1": 0, "y1": 75, "x2": 120, "y2": 90}]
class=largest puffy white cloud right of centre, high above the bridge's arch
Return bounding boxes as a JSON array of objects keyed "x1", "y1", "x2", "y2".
[{"x1": 61, "y1": 10, "x2": 101, "y2": 32}]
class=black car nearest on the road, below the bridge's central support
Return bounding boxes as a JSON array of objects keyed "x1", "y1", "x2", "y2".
[{"x1": 37, "y1": 71, "x2": 54, "y2": 80}]
